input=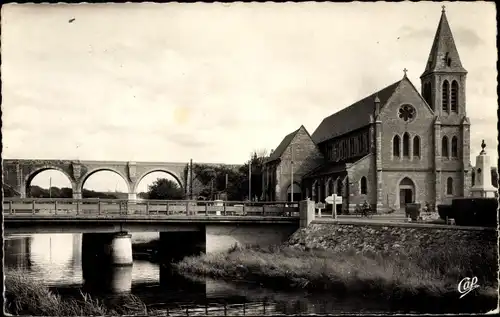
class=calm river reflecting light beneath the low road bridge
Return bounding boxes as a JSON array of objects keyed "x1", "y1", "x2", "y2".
[{"x1": 4, "y1": 234, "x2": 492, "y2": 316}]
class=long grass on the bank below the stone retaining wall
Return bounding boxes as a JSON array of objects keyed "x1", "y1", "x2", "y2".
[{"x1": 174, "y1": 244, "x2": 497, "y2": 299}]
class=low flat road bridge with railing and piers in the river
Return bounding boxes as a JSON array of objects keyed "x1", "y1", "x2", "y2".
[{"x1": 3, "y1": 198, "x2": 300, "y2": 265}]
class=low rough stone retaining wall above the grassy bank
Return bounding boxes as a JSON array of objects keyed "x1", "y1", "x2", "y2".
[{"x1": 287, "y1": 223, "x2": 498, "y2": 252}]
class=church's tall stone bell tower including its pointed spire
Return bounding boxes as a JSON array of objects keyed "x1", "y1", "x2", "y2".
[{"x1": 420, "y1": 6, "x2": 471, "y2": 200}]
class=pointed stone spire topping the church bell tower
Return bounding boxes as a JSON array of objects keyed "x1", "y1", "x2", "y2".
[{"x1": 422, "y1": 6, "x2": 467, "y2": 76}]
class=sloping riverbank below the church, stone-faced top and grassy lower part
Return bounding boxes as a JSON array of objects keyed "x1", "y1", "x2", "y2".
[{"x1": 175, "y1": 225, "x2": 498, "y2": 303}]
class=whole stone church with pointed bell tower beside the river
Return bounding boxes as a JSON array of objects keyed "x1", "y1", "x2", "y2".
[{"x1": 262, "y1": 8, "x2": 472, "y2": 212}]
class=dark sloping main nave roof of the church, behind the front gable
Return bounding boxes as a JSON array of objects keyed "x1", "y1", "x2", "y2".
[{"x1": 312, "y1": 80, "x2": 401, "y2": 144}]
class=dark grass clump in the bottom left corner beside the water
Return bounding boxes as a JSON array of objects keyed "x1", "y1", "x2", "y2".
[{"x1": 5, "y1": 270, "x2": 148, "y2": 316}]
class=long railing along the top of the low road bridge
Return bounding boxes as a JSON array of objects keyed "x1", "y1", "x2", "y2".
[{"x1": 3, "y1": 198, "x2": 299, "y2": 216}]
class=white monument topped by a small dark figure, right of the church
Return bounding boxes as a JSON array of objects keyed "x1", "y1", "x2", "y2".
[{"x1": 470, "y1": 140, "x2": 497, "y2": 198}]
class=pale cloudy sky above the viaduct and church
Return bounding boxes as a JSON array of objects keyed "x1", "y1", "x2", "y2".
[{"x1": 1, "y1": 2, "x2": 497, "y2": 190}]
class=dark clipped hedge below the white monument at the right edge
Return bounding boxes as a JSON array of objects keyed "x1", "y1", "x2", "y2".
[{"x1": 452, "y1": 197, "x2": 498, "y2": 227}]
